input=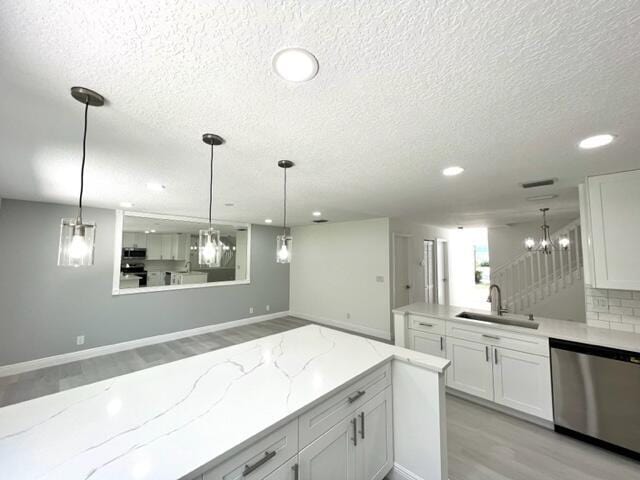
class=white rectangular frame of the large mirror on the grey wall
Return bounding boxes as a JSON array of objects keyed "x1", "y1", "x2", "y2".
[{"x1": 111, "y1": 210, "x2": 253, "y2": 296}]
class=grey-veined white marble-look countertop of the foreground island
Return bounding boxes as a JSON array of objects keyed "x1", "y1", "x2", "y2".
[{"x1": 0, "y1": 325, "x2": 449, "y2": 480}]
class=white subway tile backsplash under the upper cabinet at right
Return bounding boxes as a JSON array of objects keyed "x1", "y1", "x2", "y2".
[{"x1": 584, "y1": 285, "x2": 640, "y2": 333}]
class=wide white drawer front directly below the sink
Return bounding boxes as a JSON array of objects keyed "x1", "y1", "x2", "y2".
[{"x1": 447, "y1": 322, "x2": 549, "y2": 357}]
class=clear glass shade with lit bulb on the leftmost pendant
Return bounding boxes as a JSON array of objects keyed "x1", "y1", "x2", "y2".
[{"x1": 58, "y1": 218, "x2": 96, "y2": 267}]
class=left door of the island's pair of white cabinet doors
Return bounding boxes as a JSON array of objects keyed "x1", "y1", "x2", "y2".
[{"x1": 298, "y1": 416, "x2": 358, "y2": 480}]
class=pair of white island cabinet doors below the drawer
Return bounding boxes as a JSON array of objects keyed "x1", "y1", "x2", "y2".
[{"x1": 299, "y1": 388, "x2": 393, "y2": 480}]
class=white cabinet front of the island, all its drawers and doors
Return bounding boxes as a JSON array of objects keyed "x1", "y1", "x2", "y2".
[{"x1": 200, "y1": 364, "x2": 393, "y2": 480}]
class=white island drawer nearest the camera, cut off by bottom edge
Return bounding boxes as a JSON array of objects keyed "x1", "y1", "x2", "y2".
[{"x1": 202, "y1": 419, "x2": 298, "y2": 480}]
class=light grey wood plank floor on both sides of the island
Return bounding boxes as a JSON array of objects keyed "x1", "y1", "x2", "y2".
[{"x1": 0, "y1": 317, "x2": 640, "y2": 480}]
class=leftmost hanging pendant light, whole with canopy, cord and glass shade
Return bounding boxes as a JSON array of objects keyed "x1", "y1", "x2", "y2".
[{"x1": 58, "y1": 87, "x2": 104, "y2": 267}]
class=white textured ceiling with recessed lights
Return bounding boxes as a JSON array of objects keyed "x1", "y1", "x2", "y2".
[{"x1": 0, "y1": 0, "x2": 640, "y2": 225}]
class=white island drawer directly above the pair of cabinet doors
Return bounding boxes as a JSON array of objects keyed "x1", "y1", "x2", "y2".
[{"x1": 299, "y1": 363, "x2": 391, "y2": 449}]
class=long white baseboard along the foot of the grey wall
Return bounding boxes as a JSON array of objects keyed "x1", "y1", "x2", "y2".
[{"x1": 0, "y1": 311, "x2": 289, "y2": 377}]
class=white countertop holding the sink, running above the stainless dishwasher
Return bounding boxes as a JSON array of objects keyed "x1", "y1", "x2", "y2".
[{"x1": 393, "y1": 302, "x2": 640, "y2": 352}]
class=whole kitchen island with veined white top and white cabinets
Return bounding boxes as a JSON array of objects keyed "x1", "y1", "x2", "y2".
[{"x1": 0, "y1": 325, "x2": 449, "y2": 480}]
